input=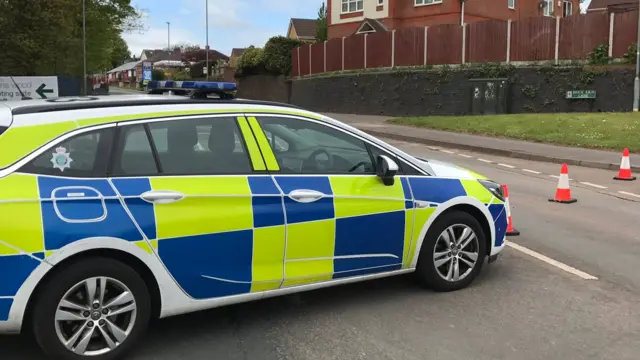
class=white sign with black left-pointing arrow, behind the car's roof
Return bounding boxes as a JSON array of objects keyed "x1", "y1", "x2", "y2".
[{"x1": 0, "y1": 76, "x2": 58, "y2": 100}]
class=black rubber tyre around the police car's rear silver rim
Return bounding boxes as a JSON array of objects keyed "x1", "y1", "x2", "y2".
[{"x1": 31, "y1": 257, "x2": 151, "y2": 360}]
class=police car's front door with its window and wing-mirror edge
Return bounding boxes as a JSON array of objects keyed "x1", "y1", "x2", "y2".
[{"x1": 242, "y1": 114, "x2": 413, "y2": 286}]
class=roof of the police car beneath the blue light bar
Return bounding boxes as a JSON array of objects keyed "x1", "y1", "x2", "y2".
[{"x1": 3, "y1": 94, "x2": 297, "y2": 115}]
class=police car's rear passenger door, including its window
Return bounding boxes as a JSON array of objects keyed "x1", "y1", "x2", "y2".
[{"x1": 111, "y1": 115, "x2": 285, "y2": 299}]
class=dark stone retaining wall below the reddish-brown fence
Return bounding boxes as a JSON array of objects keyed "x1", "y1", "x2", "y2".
[{"x1": 239, "y1": 64, "x2": 635, "y2": 116}]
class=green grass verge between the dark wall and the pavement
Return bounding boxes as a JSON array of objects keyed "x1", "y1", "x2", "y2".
[{"x1": 389, "y1": 113, "x2": 640, "y2": 152}]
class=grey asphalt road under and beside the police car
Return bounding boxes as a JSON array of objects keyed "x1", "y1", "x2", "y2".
[{"x1": 0, "y1": 142, "x2": 640, "y2": 360}]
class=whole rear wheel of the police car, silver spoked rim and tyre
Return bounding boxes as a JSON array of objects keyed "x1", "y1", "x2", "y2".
[{"x1": 32, "y1": 258, "x2": 151, "y2": 360}]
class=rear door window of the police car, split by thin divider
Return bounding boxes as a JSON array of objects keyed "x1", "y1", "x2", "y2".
[{"x1": 114, "y1": 117, "x2": 252, "y2": 176}]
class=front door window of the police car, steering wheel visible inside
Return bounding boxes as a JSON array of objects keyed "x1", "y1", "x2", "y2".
[{"x1": 257, "y1": 116, "x2": 375, "y2": 174}]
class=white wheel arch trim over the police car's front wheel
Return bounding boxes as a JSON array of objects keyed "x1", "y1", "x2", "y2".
[{"x1": 410, "y1": 196, "x2": 495, "y2": 268}]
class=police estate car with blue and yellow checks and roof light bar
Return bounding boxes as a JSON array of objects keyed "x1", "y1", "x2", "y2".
[{"x1": 0, "y1": 81, "x2": 507, "y2": 359}]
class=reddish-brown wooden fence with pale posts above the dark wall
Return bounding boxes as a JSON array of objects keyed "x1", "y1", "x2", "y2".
[{"x1": 291, "y1": 11, "x2": 638, "y2": 76}]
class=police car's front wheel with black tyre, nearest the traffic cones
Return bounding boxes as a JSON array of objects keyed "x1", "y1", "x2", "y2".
[{"x1": 416, "y1": 210, "x2": 487, "y2": 292}]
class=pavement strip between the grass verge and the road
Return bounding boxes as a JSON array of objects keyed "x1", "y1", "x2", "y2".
[{"x1": 325, "y1": 114, "x2": 640, "y2": 171}]
